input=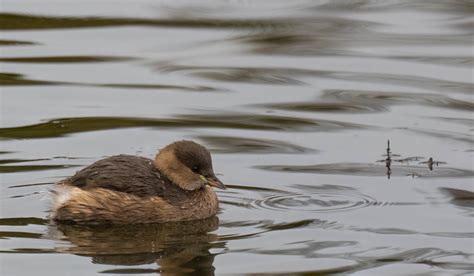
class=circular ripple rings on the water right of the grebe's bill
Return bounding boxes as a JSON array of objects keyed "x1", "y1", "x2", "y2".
[{"x1": 251, "y1": 192, "x2": 377, "y2": 212}]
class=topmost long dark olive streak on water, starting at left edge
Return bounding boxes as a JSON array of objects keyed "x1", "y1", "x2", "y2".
[{"x1": 0, "y1": 13, "x2": 290, "y2": 30}]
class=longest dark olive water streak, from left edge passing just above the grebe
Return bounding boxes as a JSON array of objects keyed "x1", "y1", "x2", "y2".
[{"x1": 0, "y1": 113, "x2": 367, "y2": 139}]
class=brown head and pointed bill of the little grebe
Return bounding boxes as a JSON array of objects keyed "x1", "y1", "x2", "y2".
[{"x1": 155, "y1": 140, "x2": 225, "y2": 191}]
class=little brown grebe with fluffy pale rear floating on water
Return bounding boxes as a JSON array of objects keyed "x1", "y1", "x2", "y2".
[{"x1": 51, "y1": 141, "x2": 225, "y2": 224}]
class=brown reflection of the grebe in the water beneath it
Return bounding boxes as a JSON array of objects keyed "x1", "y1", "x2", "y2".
[{"x1": 49, "y1": 216, "x2": 225, "y2": 275}]
